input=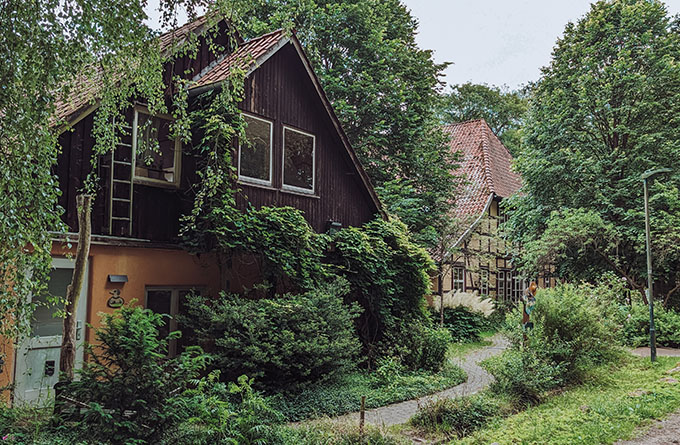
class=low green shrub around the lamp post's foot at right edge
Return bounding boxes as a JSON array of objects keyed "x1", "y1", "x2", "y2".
[{"x1": 621, "y1": 304, "x2": 680, "y2": 348}]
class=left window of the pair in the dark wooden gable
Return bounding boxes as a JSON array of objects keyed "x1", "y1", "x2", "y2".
[{"x1": 238, "y1": 114, "x2": 274, "y2": 186}]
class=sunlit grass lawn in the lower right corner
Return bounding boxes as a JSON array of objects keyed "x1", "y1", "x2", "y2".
[{"x1": 451, "y1": 357, "x2": 680, "y2": 445}]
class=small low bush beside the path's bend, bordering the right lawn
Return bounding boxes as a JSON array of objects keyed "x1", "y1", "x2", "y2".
[{"x1": 487, "y1": 350, "x2": 564, "y2": 408}]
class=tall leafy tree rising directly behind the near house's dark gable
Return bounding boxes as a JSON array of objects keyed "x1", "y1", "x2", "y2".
[{"x1": 228, "y1": 0, "x2": 452, "y2": 245}]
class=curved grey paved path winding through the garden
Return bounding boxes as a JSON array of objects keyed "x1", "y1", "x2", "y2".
[{"x1": 333, "y1": 334, "x2": 508, "y2": 426}]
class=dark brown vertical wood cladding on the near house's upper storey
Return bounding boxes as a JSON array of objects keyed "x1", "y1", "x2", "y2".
[{"x1": 55, "y1": 21, "x2": 380, "y2": 243}]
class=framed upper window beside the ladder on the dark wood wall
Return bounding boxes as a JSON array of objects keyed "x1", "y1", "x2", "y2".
[{"x1": 132, "y1": 108, "x2": 182, "y2": 187}]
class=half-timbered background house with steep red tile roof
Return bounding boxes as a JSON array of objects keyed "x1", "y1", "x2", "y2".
[{"x1": 434, "y1": 119, "x2": 555, "y2": 303}]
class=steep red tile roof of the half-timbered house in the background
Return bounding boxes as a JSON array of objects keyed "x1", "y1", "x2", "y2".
[{"x1": 443, "y1": 119, "x2": 522, "y2": 219}]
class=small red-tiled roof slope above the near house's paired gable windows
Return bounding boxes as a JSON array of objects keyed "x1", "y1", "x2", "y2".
[{"x1": 191, "y1": 29, "x2": 286, "y2": 88}]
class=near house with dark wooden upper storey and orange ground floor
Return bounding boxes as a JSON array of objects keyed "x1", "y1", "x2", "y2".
[{"x1": 6, "y1": 17, "x2": 382, "y2": 403}]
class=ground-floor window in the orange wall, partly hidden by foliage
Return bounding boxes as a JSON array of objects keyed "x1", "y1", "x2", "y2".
[{"x1": 146, "y1": 287, "x2": 196, "y2": 357}]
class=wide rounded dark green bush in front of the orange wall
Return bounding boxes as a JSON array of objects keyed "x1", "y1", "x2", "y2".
[{"x1": 180, "y1": 280, "x2": 359, "y2": 387}]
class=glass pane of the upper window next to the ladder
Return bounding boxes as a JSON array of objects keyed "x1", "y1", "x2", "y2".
[{"x1": 135, "y1": 112, "x2": 175, "y2": 183}]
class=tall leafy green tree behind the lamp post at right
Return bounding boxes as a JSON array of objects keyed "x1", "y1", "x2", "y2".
[{"x1": 509, "y1": 0, "x2": 680, "y2": 304}]
